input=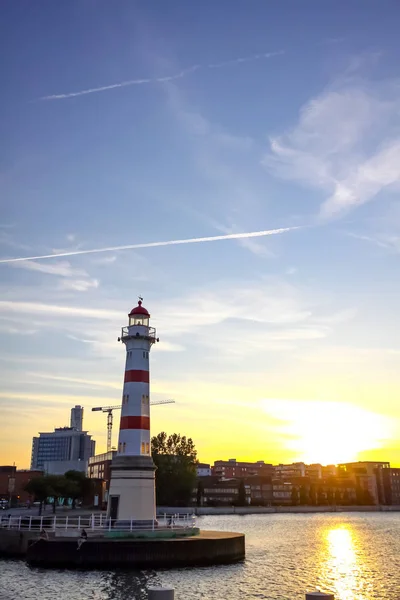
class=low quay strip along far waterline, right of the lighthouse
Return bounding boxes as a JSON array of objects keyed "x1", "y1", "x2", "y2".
[{"x1": 157, "y1": 505, "x2": 400, "y2": 517}]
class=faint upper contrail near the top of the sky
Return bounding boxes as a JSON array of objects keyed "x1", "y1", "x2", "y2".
[{"x1": 39, "y1": 50, "x2": 284, "y2": 100}]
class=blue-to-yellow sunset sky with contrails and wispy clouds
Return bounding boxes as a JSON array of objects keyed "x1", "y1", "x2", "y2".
[{"x1": 0, "y1": 0, "x2": 400, "y2": 468}]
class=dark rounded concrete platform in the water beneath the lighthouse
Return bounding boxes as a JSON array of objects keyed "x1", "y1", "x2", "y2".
[{"x1": 26, "y1": 531, "x2": 245, "y2": 569}]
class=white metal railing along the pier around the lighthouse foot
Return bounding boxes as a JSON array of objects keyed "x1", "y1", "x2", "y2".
[{"x1": 0, "y1": 513, "x2": 196, "y2": 536}]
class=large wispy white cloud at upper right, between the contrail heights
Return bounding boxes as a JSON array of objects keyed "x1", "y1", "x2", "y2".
[{"x1": 262, "y1": 78, "x2": 400, "y2": 220}]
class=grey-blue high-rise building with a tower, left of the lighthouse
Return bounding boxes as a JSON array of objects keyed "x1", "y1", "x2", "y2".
[{"x1": 31, "y1": 406, "x2": 96, "y2": 475}]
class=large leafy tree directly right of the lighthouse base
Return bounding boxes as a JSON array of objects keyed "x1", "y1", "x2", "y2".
[{"x1": 151, "y1": 431, "x2": 197, "y2": 506}]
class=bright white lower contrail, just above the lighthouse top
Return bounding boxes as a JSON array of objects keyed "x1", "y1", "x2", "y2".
[{"x1": 0, "y1": 226, "x2": 302, "y2": 263}]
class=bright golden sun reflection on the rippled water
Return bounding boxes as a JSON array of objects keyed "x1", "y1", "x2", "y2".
[{"x1": 324, "y1": 525, "x2": 371, "y2": 600}]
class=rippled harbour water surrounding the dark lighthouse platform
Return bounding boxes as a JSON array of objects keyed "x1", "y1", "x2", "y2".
[{"x1": 0, "y1": 513, "x2": 400, "y2": 600}]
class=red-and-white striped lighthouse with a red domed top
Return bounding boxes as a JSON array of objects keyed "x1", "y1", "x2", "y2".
[{"x1": 107, "y1": 298, "x2": 158, "y2": 525}]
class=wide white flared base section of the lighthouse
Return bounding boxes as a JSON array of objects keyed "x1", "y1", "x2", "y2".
[{"x1": 107, "y1": 456, "x2": 156, "y2": 526}]
